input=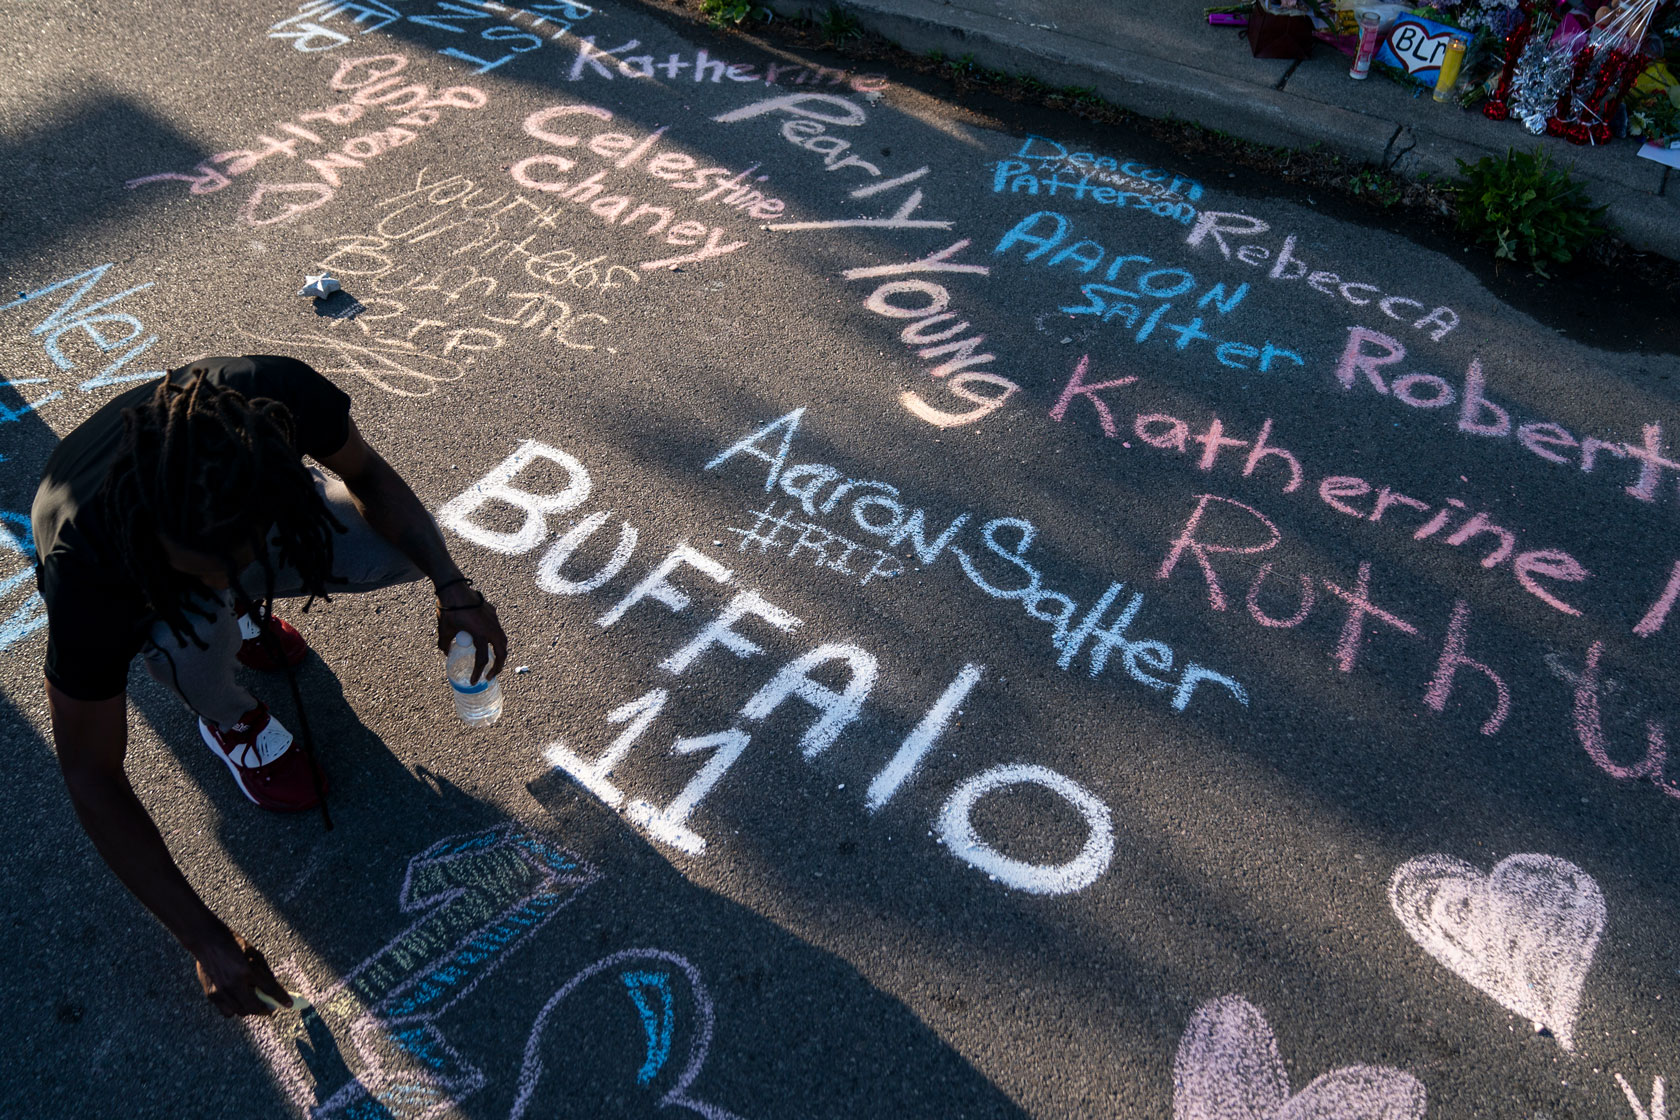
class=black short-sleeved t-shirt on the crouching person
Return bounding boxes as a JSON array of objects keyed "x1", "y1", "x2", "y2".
[{"x1": 30, "y1": 356, "x2": 349, "y2": 700}]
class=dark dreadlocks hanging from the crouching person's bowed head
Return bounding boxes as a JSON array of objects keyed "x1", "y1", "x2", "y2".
[{"x1": 104, "y1": 368, "x2": 344, "y2": 648}]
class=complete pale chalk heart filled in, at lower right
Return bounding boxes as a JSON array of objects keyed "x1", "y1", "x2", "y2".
[{"x1": 1388, "y1": 853, "x2": 1604, "y2": 1049}]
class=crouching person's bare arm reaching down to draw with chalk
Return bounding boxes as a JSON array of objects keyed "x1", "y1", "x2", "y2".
[{"x1": 47, "y1": 682, "x2": 289, "y2": 1016}]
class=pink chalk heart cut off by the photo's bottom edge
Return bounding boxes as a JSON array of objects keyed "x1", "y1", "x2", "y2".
[{"x1": 1173, "y1": 996, "x2": 1426, "y2": 1120}]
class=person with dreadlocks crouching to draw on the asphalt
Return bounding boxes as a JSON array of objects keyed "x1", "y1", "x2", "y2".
[{"x1": 30, "y1": 356, "x2": 507, "y2": 1016}]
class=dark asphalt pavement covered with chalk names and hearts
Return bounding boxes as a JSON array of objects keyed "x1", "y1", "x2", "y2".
[{"x1": 0, "y1": 0, "x2": 1680, "y2": 1120}]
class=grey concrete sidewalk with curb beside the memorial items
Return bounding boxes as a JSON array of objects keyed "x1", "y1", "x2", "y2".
[{"x1": 771, "y1": 0, "x2": 1680, "y2": 259}]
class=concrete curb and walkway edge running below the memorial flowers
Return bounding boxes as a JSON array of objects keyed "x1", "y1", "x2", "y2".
[{"x1": 768, "y1": 0, "x2": 1680, "y2": 259}]
